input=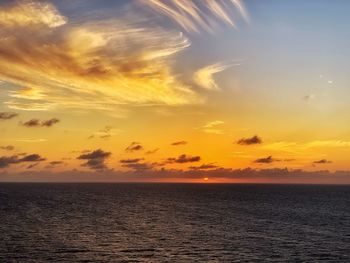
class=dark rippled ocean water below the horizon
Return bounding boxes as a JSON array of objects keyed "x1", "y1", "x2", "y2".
[{"x1": 0, "y1": 184, "x2": 350, "y2": 262}]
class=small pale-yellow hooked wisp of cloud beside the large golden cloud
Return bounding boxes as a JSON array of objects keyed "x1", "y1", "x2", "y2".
[{"x1": 193, "y1": 63, "x2": 230, "y2": 90}]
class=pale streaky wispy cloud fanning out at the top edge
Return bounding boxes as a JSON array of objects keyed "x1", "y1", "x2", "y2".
[{"x1": 141, "y1": 0, "x2": 249, "y2": 33}]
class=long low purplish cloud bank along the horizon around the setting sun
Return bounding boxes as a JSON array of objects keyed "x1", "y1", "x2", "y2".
[{"x1": 0, "y1": 168, "x2": 350, "y2": 185}]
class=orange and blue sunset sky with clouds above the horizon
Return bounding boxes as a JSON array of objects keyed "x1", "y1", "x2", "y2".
[{"x1": 0, "y1": 0, "x2": 350, "y2": 184}]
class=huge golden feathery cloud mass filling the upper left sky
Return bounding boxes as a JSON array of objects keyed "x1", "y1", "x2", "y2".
[{"x1": 0, "y1": 1, "x2": 204, "y2": 112}]
